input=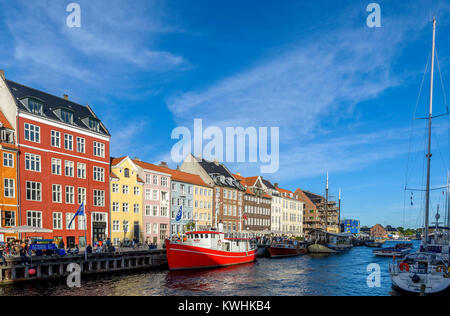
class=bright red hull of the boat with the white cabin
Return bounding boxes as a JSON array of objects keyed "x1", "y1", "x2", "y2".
[{"x1": 166, "y1": 240, "x2": 257, "y2": 270}]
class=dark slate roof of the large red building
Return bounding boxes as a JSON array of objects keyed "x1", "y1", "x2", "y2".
[{"x1": 5, "y1": 80, "x2": 110, "y2": 136}]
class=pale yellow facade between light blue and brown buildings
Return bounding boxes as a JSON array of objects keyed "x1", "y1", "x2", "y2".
[{"x1": 194, "y1": 184, "x2": 213, "y2": 229}]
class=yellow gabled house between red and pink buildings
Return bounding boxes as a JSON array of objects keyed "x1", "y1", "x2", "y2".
[{"x1": 110, "y1": 157, "x2": 144, "y2": 245}]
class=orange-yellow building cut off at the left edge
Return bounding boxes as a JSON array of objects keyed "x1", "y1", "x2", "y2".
[{"x1": 0, "y1": 111, "x2": 20, "y2": 242}]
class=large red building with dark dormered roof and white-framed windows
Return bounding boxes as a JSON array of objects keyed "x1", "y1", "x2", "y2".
[{"x1": 6, "y1": 81, "x2": 110, "y2": 247}]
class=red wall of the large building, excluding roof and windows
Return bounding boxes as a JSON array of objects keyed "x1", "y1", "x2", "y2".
[{"x1": 17, "y1": 113, "x2": 110, "y2": 245}]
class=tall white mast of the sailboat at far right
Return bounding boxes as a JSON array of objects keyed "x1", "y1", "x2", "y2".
[{"x1": 425, "y1": 18, "x2": 436, "y2": 244}]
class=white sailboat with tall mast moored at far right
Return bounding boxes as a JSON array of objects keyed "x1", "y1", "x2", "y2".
[{"x1": 389, "y1": 19, "x2": 450, "y2": 295}]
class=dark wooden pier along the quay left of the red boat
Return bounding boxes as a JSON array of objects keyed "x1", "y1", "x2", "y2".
[{"x1": 0, "y1": 249, "x2": 167, "y2": 285}]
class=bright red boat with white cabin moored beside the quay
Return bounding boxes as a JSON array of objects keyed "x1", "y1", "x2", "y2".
[{"x1": 166, "y1": 231, "x2": 257, "y2": 270}]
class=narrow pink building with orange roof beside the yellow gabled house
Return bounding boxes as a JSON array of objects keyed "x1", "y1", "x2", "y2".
[{"x1": 133, "y1": 159, "x2": 171, "y2": 247}]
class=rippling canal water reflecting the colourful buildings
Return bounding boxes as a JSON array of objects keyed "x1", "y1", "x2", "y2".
[{"x1": 0, "y1": 242, "x2": 419, "y2": 296}]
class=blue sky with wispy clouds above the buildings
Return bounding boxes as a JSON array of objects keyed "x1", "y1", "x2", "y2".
[{"x1": 0, "y1": 0, "x2": 450, "y2": 227}]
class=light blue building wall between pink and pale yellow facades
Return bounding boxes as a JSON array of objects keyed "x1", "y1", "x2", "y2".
[{"x1": 170, "y1": 180, "x2": 194, "y2": 235}]
